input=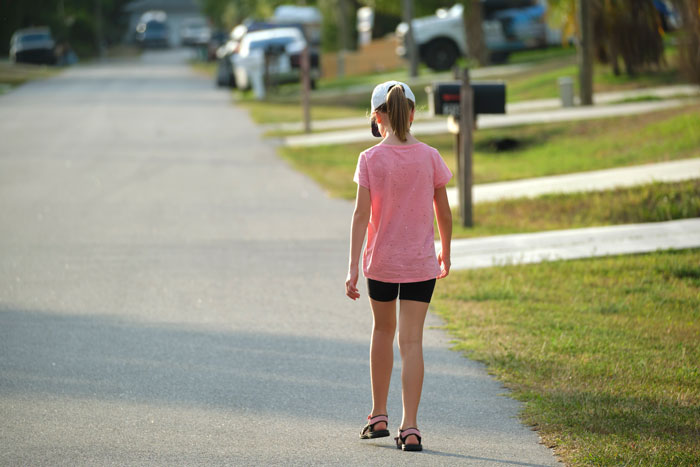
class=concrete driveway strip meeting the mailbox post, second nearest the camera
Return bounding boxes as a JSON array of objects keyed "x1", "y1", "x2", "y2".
[{"x1": 447, "y1": 158, "x2": 700, "y2": 206}]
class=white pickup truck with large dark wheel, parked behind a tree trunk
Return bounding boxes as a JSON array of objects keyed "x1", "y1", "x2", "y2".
[{"x1": 396, "y1": 0, "x2": 550, "y2": 70}]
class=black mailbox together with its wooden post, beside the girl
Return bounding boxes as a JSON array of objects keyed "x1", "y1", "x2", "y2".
[{"x1": 426, "y1": 68, "x2": 506, "y2": 227}]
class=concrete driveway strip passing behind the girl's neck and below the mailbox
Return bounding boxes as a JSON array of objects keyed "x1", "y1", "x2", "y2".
[{"x1": 281, "y1": 99, "x2": 693, "y2": 146}]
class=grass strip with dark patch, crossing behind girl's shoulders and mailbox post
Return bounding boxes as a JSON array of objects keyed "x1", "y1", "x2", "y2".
[{"x1": 279, "y1": 104, "x2": 700, "y2": 199}]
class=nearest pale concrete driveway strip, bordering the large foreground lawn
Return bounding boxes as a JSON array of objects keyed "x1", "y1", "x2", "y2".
[{"x1": 446, "y1": 219, "x2": 700, "y2": 270}]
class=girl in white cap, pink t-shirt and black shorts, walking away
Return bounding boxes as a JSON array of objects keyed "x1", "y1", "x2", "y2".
[{"x1": 345, "y1": 81, "x2": 452, "y2": 451}]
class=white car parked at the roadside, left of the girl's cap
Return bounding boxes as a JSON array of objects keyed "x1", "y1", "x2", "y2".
[{"x1": 232, "y1": 27, "x2": 320, "y2": 89}]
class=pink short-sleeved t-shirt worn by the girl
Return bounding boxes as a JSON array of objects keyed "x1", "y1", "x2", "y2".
[{"x1": 354, "y1": 143, "x2": 452, "y2": 283}]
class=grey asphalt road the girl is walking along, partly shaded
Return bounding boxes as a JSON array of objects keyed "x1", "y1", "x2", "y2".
[{"x1": 0, "y1": 51, "x2": 555, "y2": 465}]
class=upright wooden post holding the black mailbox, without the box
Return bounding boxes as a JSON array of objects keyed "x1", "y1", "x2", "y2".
[{"x1": 457, "y1": 68, "x2": 474, "y2": 227}]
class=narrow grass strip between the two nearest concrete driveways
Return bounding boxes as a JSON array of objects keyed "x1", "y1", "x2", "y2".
[{"x1": 448, "y1": 179, "x2": 700, "y2": 238}]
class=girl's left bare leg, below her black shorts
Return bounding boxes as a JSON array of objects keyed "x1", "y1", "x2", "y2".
[{"x1": 369, "y1": 299, "x2": 396, "y2": 430}]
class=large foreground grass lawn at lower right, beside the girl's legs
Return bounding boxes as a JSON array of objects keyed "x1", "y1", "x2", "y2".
[{"x1": 433, "y1": 250, "x2": 700, "y2": 466}]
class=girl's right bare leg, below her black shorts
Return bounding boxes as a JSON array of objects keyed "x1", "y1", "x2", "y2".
[{"x1": 399, "y1": 300, "x2": 429, "y2": 444}]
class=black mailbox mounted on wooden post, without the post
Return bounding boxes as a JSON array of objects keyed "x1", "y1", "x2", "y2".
[{"x1": 428, "y1": 81, "x2": 506, "y2": 117}]
